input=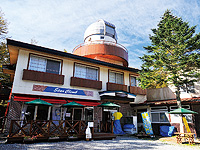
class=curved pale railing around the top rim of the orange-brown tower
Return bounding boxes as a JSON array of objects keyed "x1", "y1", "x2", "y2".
[{"x1": 72, "y1": 40, "x2": 128, "y2": 53}]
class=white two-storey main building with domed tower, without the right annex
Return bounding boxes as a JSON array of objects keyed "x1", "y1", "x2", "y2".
[{"x1": 4, "y1": 20, "x2": 146, "y2": 141}]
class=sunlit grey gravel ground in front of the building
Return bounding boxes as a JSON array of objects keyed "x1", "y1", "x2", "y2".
[{"x1": 0, "y1": 136, "x2": 200, "y2": 150}]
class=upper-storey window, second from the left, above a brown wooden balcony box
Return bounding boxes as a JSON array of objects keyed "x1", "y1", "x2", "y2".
[{"x1": 74, "y1": 64, "x2": 98, "y2": 80}]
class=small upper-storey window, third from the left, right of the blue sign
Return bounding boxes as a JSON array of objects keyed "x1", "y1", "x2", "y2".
[{"x1": 109, "y1": 71, "x2": 124, "y2": 84}]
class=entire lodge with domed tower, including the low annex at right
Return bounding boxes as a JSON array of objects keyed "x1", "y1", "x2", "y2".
[{"x1": 3, "y1": 20, "x2": 200, "y2": 141}]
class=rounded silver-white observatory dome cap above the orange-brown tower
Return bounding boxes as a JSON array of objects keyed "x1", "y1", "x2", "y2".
[{"x1": 84, "y1": 19, "x2": 117, "y2": 41}]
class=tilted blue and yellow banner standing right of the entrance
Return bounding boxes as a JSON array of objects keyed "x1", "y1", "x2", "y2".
[{"x1": 141, "y1": 112, "x2": 153, "y2": 135}]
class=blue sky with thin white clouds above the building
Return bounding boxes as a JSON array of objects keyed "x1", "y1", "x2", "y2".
[{"x1": 0, "y1": 0, "x2": 200, "y2": 68}]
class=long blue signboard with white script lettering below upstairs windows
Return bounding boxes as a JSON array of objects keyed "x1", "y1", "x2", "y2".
[{"x1": 33, "y1": 85, "x2": 93, "y2": 96}]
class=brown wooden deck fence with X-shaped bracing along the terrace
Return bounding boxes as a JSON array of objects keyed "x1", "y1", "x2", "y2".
[{"x1": 9, "y1": 120, "x2": 94, "y2": 138}]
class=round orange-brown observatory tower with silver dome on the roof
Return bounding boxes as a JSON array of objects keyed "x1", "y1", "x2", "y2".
[{"x1": 73, "y1": 19, "x2": 128, "y2": 67}]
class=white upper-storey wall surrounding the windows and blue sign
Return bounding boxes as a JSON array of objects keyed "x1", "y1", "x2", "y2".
[{"x1": 12, "y1": 49, "x2": 146, "y2": 103}]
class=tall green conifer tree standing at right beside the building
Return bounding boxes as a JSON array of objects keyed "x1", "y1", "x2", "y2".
[{"x1": 139, "y1": 10, "x2": 200, "y2": 107}]
